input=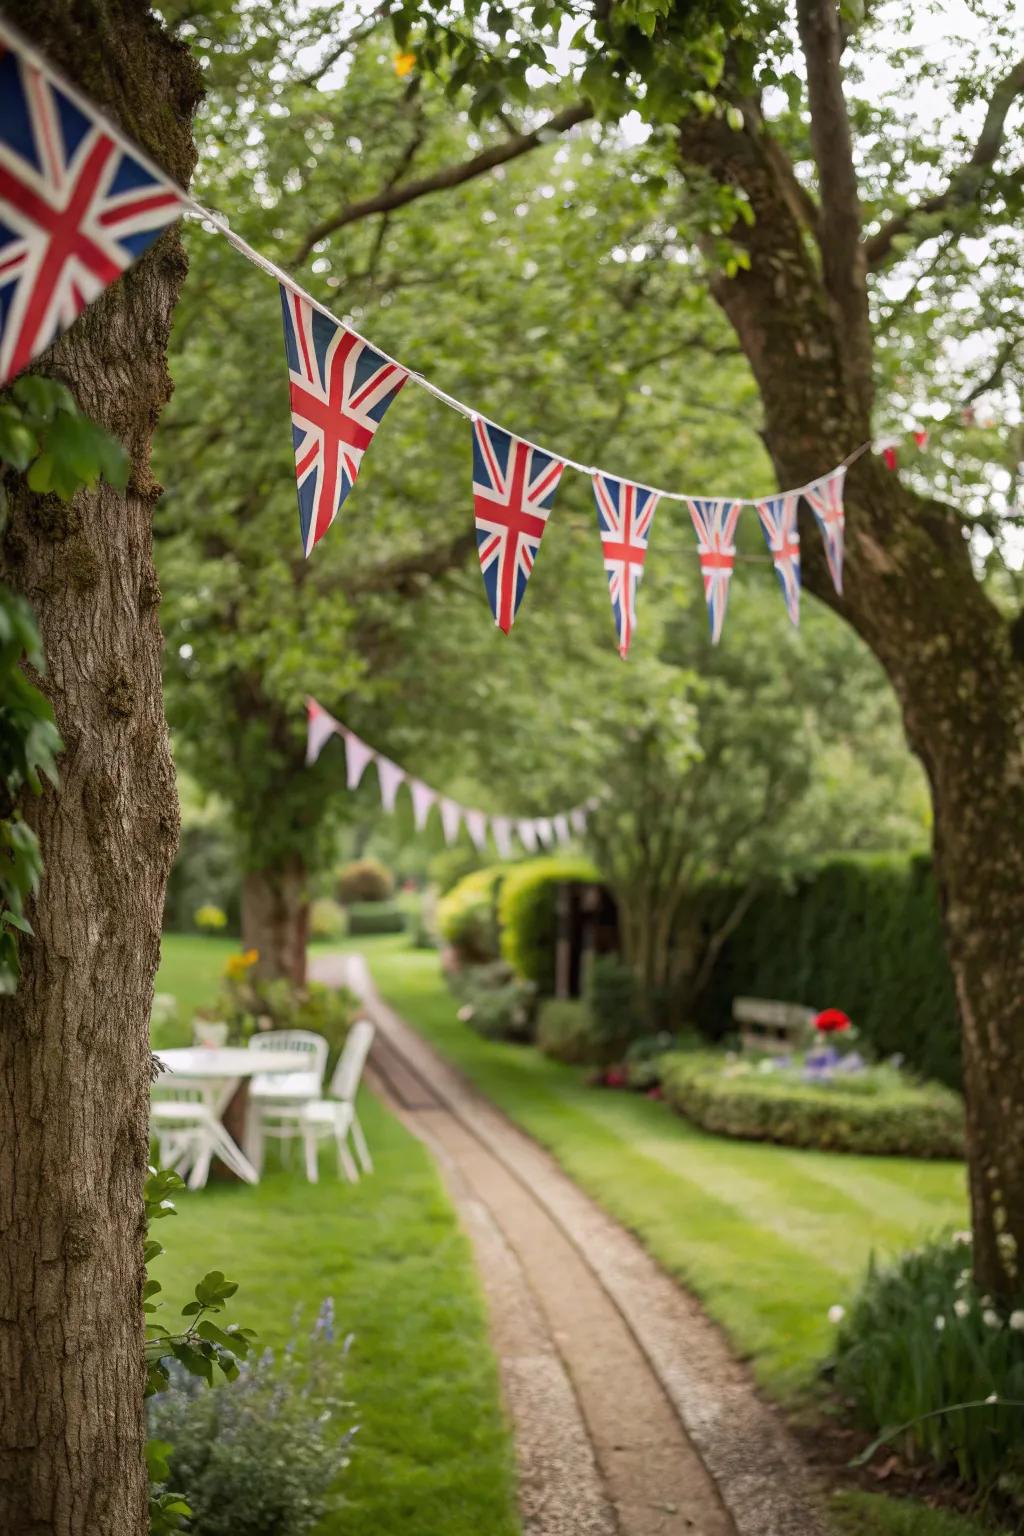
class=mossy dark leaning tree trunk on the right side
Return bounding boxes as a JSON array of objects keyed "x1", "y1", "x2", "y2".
[{"x1": 682, "y1": 105, "x2": 1024, "y2": 1298}]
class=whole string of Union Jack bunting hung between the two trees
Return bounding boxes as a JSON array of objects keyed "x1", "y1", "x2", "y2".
[{"x1": 0, "y1": 22, "x2": 870, "y2": 651}]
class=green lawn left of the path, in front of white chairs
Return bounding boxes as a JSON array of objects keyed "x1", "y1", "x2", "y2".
[{"x1": 154, "y1": 1093, "x2": 519, "y2": 1536}]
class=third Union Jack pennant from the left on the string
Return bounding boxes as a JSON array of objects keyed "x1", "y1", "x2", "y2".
[{"x1": 473, "y1": 416, "x2": 565, "y2": 634}]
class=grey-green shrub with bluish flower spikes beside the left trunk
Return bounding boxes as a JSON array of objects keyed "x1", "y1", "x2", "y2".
[{"x1": 149, "y1": 1303, "x2": 352, "y2": 1536}]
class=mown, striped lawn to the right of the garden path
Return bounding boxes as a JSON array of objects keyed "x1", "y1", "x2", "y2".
[{"x1": 361, "y1": 942, "x2": 966, "y2": 1399}]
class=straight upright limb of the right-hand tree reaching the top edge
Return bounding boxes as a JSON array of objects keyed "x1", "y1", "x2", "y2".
[{"x1": 797, "y1": 0, "x2": 870, "y2": 402}]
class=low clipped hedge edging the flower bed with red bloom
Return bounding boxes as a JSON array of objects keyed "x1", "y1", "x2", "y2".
[{"x1": 660, "y1": 1051, "x2": 964, "y2": 1158}]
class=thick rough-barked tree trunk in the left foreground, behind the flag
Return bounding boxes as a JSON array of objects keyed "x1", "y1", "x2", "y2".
[{"x1": 0, "y1": 0, "x2": 198, "y2": 1536}]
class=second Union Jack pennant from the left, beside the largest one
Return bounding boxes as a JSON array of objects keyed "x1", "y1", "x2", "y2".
[{"x1": 281, "y1": 286, "x2": 408, "y2": 554}]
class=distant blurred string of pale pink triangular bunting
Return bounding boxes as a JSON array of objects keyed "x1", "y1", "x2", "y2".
[{"x1": 306, "y1": 697, "x2": 597, "y2": 859}]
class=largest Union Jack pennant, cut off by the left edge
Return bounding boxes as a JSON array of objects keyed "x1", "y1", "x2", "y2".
[{"x1": 0, "y1": 26, "x2": 181, "y2": 386}]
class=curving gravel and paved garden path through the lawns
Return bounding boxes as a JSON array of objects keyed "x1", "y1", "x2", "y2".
[{"x1": 312, "y1": 954, "x2": 823, "y2": 1536}]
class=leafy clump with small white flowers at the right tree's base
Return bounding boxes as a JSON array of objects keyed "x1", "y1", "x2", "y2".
[{"x1": 835, "y1": 1233, "x2": 1024, "y2": 1498}]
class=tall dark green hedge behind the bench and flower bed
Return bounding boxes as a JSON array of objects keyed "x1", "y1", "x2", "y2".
[{"x1": 695, "y1": 854, "x2": 961, "y2": 1087}]
